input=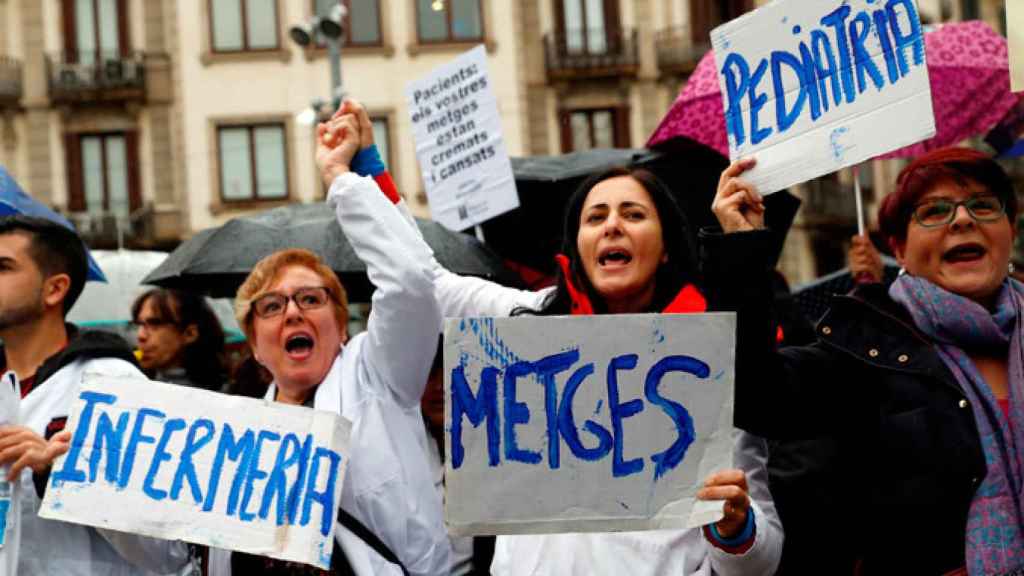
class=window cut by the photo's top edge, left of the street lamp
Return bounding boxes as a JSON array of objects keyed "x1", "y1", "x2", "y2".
[{"x1": 209, "y1": 0, "x2": 278, "y2": 52}]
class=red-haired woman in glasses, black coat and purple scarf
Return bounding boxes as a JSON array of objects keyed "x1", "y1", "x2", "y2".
[{"x1": 703, "y1": 149, "x2": 1024, "y2": 575}]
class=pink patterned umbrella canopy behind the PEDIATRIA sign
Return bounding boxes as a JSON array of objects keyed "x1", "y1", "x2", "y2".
[{"x1": 647, "y1": 20, "x2": 1019, "y2": 158}]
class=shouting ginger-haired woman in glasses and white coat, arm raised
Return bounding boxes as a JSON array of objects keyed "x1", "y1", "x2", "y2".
[{"x1": 210, "y1": 108, "x2": 450, "y2": 576}]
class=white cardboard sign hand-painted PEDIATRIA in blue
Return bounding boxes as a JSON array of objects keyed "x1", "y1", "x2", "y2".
[{"x1": 711, "y1": 0, "x2": 935, "y2": 194}]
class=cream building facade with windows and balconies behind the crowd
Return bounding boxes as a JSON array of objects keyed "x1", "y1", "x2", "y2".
[{"x1": 0, "y1": 0, "x2": 1005, "y2": 283}]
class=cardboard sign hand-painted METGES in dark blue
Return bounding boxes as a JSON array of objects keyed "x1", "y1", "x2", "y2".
[{"x1": 444, "y1": 314, "x2": 735, "y2": 535}]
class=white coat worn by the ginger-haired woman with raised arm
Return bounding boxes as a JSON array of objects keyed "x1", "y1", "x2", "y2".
[{"x1": 210, "y1": 173, "x2": 450, "y2": 576}]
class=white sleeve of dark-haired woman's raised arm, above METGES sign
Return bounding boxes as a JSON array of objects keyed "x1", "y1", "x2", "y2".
[{"x1": 396, "y1": 200, "x2": 551, "y2": 318}]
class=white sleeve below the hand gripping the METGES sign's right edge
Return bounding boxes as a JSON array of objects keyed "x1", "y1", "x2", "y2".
[{"x1": 708, "y1": 429, "x2": 783, "y2": 576}]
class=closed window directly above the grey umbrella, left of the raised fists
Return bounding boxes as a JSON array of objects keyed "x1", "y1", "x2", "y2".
[{"x1": 217, "y1": 124, "x2": 288, "y2": 202}]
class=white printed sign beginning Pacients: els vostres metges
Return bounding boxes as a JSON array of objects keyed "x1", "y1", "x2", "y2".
[{"x1": 407, "y1": 46, "x2": 519, "y2": 230}]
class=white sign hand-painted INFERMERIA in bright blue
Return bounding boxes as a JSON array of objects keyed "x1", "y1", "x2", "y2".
[{"x1": 39, "y1": 374, "x2": 350, "y2": 569}]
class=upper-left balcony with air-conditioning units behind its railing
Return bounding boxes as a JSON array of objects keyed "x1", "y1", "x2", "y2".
[{"x1": 46, "y1": 52, "x2": 145, "y2": 105}]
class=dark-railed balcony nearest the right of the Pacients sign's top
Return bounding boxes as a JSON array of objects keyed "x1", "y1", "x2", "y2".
[{"x1": 544, "y1": 29, "x2": 640, "y2": 81}]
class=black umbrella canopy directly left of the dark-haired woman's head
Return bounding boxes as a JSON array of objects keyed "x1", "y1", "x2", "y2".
[{"x1": 481, "y1": 149, "x2": 648, "y2": 272}]
